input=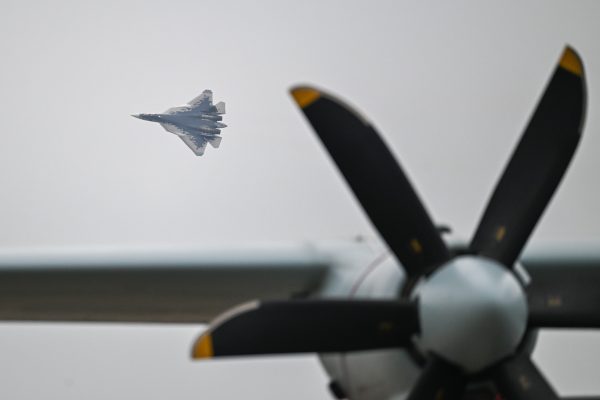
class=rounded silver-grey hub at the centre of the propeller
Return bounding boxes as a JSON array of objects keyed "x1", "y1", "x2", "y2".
[{"x1": 416, "y1": 256, "x2": 527, "y2": 373}]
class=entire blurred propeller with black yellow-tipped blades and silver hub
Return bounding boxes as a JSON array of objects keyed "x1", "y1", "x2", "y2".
[{"x1": 193, "y1": 47, "x2": 600, "y2": 400}]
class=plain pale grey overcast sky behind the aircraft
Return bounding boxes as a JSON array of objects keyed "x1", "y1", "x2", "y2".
[{"x1": 0, "y1": 0, "x2": 600, "y2": 400}]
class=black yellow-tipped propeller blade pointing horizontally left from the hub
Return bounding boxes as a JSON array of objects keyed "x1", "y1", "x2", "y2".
[{"x1": 192, "y1": 300, "x2": 419, "y2": 358}]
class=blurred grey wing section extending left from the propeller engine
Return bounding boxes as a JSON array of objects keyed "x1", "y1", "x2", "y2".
[{"x1": 0, "y1": 246, "x2": 331, "y2": 323}]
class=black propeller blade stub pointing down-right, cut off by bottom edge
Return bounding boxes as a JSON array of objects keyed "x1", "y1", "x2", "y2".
[{"x1": 492, "y1": 354, "x2": 559, "y2": 400}]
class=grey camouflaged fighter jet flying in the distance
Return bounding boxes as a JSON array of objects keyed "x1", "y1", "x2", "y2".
[{"x1": 132, "y1": 90, "x2": 227, "y2": 156}]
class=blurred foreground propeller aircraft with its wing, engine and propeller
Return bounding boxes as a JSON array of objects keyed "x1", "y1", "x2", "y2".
[{"x1": 0, "y1": 47, "x2": 600, "y2": 400}]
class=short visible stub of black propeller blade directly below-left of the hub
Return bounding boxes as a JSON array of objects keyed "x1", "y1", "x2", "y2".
[{"x1": 407, "y1": 356, "x2": 467, "y2": 400}]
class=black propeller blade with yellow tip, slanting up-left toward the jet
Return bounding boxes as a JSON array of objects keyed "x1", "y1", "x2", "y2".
[{"x1": 291, "y1": 87, "x2": 449, "y2": 277}]
